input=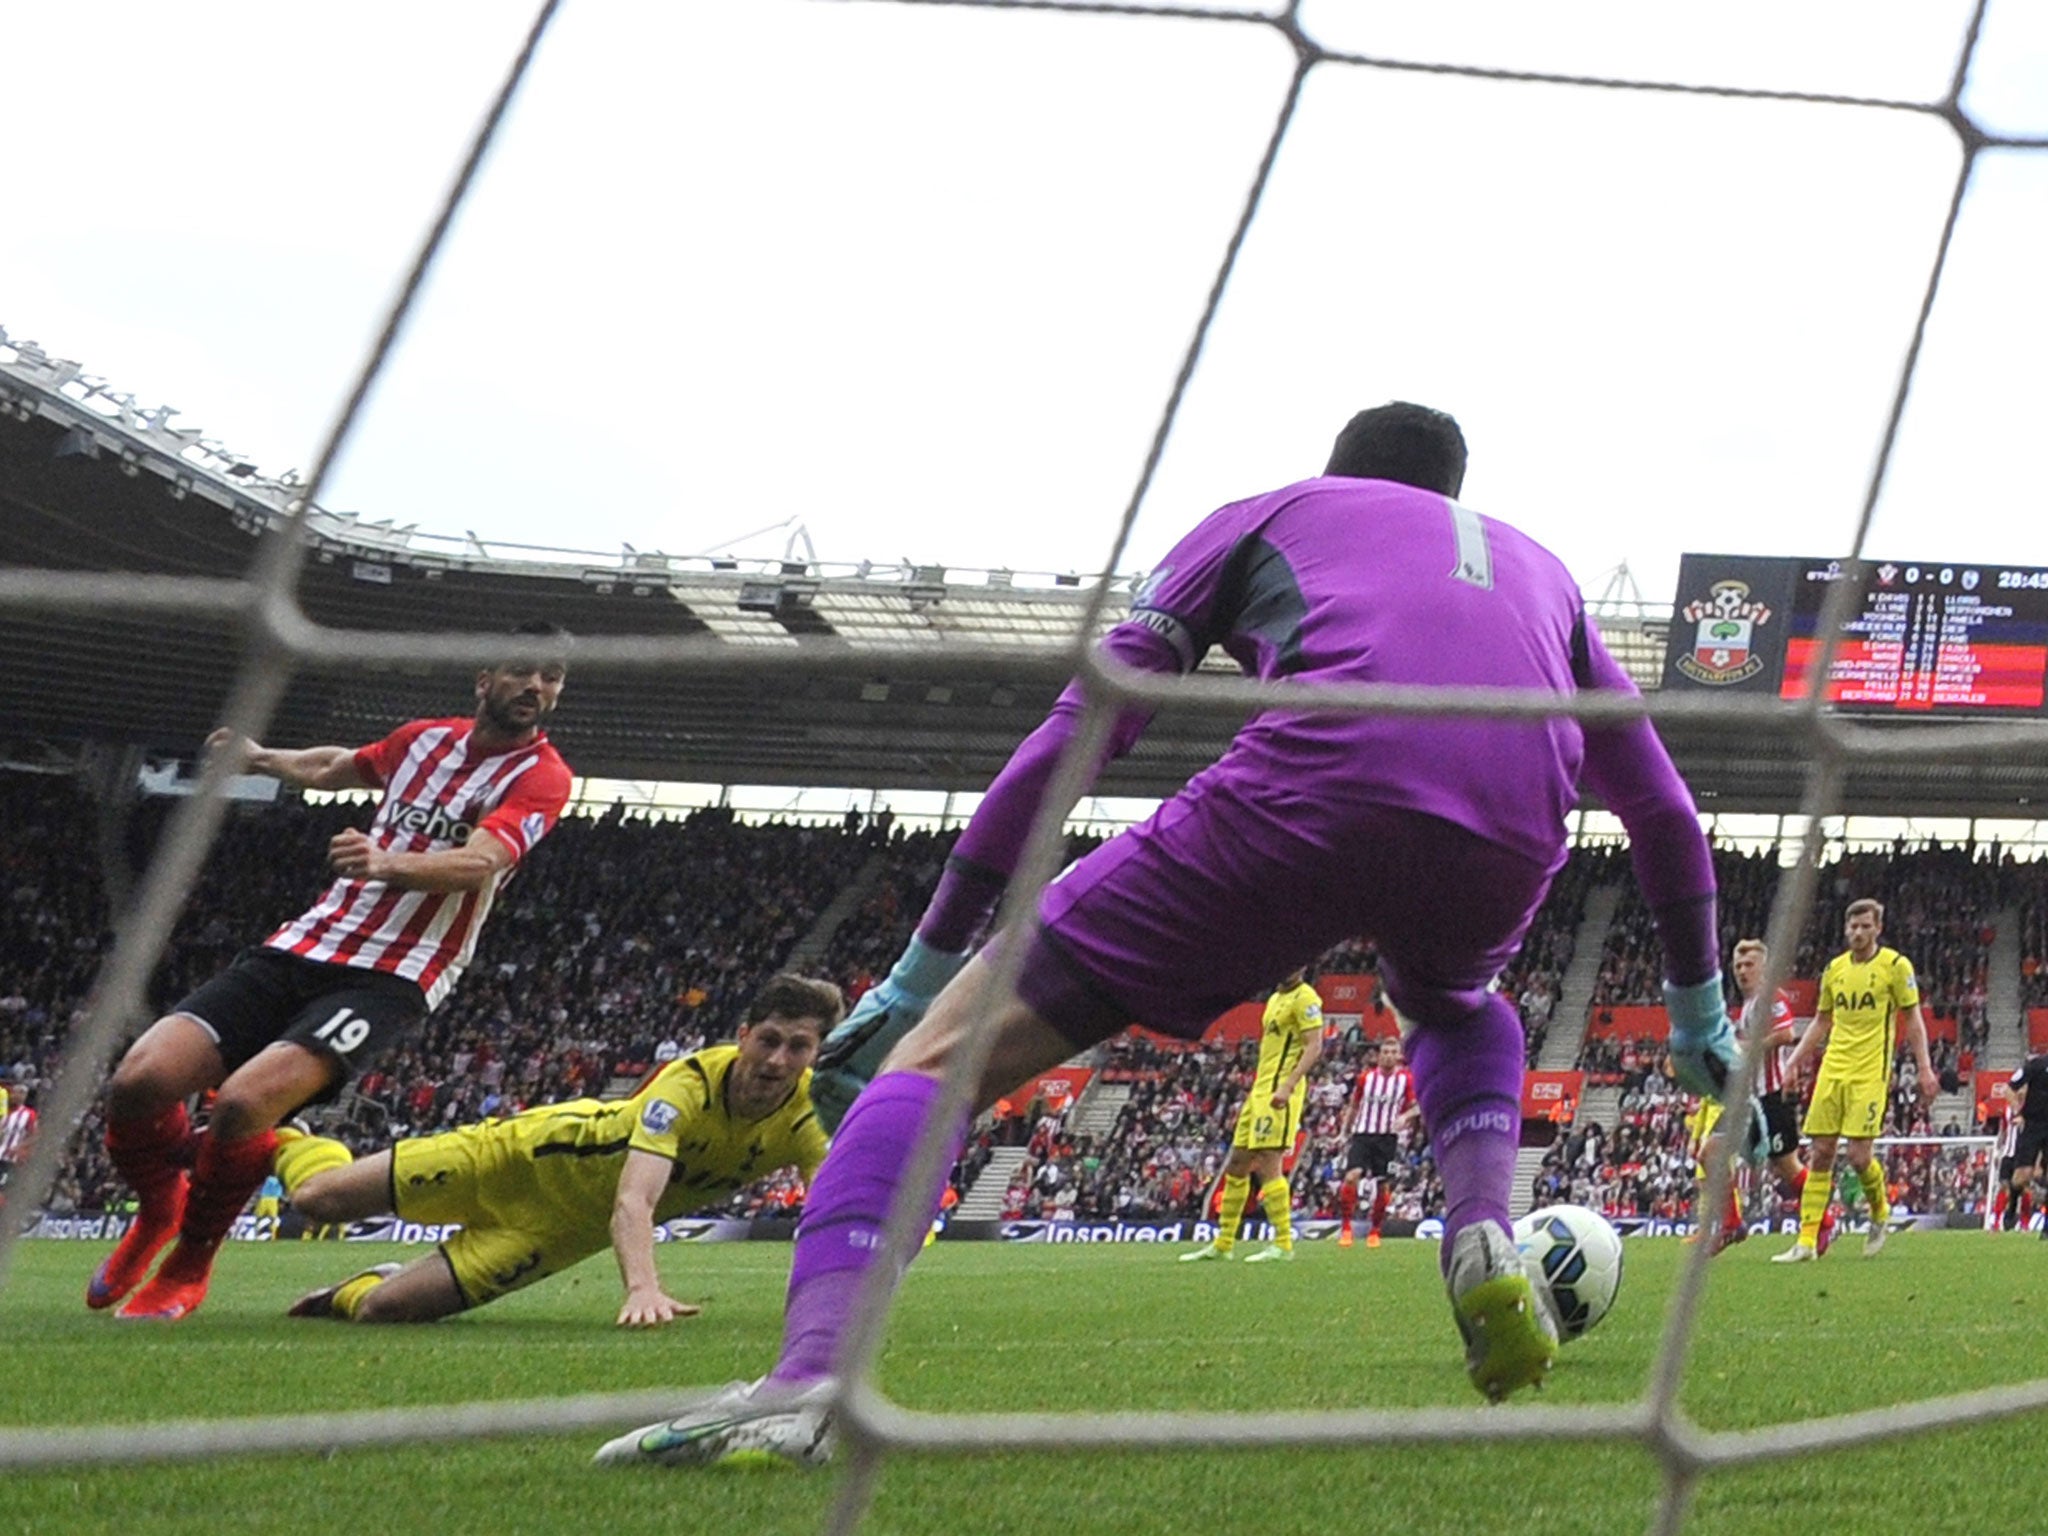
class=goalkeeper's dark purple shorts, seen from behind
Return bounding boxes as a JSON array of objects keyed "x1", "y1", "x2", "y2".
[{"x1": 1018, "y1": 782, "x2": 1565, "y2": 1044}]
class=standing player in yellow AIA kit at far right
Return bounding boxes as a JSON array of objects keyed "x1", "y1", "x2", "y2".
[{"x1": 1774, "y1": 897, "x2": 1942, "y2": 1264}]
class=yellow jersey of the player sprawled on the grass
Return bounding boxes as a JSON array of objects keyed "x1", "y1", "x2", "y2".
[{"x1": 498, "y1": 1044, "x2": 825, "y2": 1223}]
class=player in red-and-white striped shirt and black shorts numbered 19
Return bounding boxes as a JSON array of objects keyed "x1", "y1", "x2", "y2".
[{"x1": 86, "y1": 625, "x2": 569, "y2": 1321}]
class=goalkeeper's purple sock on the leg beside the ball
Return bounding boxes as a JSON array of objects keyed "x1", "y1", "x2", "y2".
[{"x1": 1407, "y1": 993, "x2": 1524, "y2": 1264}]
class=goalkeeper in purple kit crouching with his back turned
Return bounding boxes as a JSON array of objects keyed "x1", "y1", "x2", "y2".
[{"x1": 600, "y1": 403, "x2": 1761, "y2": 1464}]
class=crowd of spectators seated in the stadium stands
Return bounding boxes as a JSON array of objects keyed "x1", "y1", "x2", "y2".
[{"x1": 0, "y1": 772, "x2": 2048, "y2": 1221}]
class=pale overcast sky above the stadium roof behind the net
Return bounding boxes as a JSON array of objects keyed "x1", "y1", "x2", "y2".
[{"x1": 0, "y1": 0, "x2": 2048, "y2": 598}]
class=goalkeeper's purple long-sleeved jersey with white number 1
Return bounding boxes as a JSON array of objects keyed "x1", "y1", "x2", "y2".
[{"x1": 918, "y1": 475, "x2": 1716, "y2": 983}]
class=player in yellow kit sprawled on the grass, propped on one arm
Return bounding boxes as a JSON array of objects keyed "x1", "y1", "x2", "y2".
[{"x1": 276, "y1": 975, "x2": 844, "y2": 1327}]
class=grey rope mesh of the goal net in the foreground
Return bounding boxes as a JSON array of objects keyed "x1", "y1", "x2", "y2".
[{"x1": 0, "y1": 0, "x2": 2048, "y2": 1532}]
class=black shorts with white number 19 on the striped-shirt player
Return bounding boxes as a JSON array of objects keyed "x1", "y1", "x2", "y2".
[{"x1": 170, "y1": 944, "x2": 426, "y2": 1104}]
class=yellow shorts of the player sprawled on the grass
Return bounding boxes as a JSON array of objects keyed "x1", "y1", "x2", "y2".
[{"x1": 391, "y1": 1122, "x2": 612, "y2": 1307}]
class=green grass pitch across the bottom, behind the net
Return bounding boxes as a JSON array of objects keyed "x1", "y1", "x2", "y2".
[{"x1": 0, "y1": 1233, "x2": 2048, "y2": 1536}]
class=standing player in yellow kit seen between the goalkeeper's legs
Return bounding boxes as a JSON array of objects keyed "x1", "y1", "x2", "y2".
[{"x1": 1180, "y1": 971, "x2": 1323, "y2": 1264}]
